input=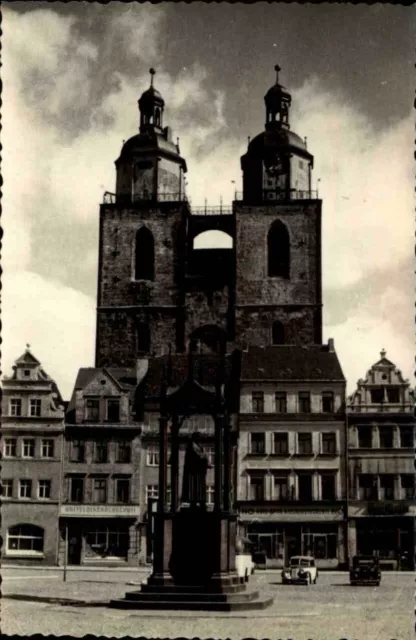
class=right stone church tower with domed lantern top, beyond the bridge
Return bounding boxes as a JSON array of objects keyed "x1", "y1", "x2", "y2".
[{"x1": 234, "y1": 66, "x2": 322, "y2": 346}]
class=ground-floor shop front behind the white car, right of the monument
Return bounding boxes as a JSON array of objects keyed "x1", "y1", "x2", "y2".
[{"x1": 240, "y1": 507, "x2": 346, "y2": 569}]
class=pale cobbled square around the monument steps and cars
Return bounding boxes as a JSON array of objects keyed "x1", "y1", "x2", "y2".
[{"x1": 1, "y1": 570, "x2": 415, "y2": 640}]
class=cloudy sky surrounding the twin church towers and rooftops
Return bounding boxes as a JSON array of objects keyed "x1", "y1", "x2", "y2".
[{"x1": 2, "y1": 0, "x2": 415, "y2": 398}]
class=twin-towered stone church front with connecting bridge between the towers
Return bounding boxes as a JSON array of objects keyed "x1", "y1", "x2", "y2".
[{"x1": 96, "y1": 66, "x2": 322, "y2": 367}]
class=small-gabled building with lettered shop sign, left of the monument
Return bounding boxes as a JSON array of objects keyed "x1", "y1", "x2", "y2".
[{"x1": 59, "y1": 368, "x2": 141, "y2": 566}]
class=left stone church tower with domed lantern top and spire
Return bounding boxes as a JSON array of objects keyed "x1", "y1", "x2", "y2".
[{"x1": 96, "y1": 69, "x2": 188, "y2": 367}]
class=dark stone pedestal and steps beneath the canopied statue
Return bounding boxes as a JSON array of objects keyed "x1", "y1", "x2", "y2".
[{"x1": 110, "y1": 510, "x2": 273, "y2": 611}]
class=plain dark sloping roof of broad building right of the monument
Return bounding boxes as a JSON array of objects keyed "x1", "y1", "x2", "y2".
[{"x1": 241, "y1": 345, "x2": 345, "y2": 381}]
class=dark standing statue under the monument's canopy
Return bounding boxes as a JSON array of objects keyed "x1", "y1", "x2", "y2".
[{"x1": 182, "y1": 432, "x2": 212, "y2": 508}]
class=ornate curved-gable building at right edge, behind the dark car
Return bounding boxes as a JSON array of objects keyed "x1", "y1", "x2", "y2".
[{"x1": 347, "y1": 350, "x2": 416, "y2": 569}]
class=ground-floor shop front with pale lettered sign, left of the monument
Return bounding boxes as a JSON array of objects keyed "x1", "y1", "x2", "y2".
[{"x1": 59, "y1": 505, "x2": 140, "y2": 566}]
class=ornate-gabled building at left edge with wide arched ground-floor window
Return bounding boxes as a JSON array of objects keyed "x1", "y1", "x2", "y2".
[{"x1": 1, "y1": 347, "x2": 64, "y2": 565}]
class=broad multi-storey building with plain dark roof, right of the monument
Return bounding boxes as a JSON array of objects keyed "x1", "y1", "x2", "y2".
[{"x1": 238, "y1": 340, "x2": 347, "y2": 568}]
